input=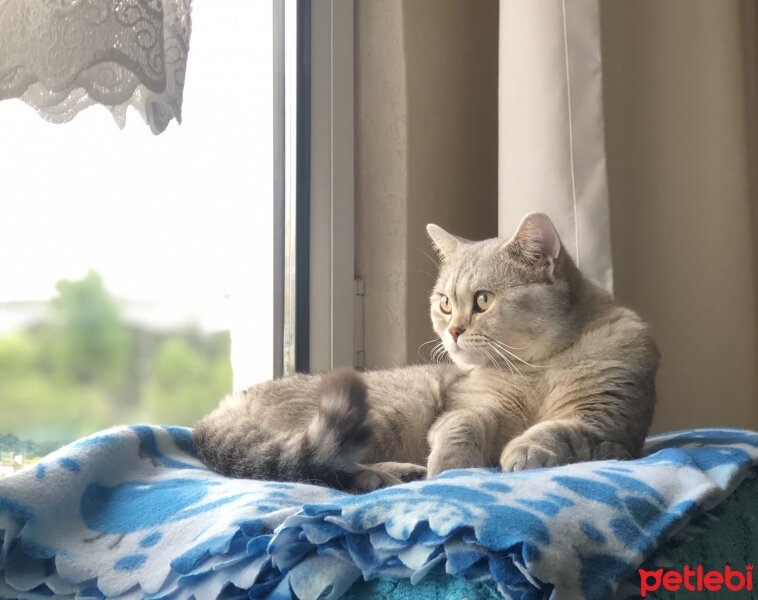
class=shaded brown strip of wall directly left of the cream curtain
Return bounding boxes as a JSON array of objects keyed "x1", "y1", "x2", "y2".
[{"x1": 404, "y1": 0, "x2": 498, "y2": 362}]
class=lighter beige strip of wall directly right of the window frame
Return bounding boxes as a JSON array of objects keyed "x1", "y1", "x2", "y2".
[{"x1": 354, "y1": 0, "x2": 408, "y2": 368}]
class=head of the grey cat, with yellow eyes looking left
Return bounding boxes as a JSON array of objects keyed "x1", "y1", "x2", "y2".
[{"x1": 427, "y1": 213, "x2": 592, "y2": 367}]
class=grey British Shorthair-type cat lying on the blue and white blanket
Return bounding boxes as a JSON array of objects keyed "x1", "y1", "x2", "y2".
[{"x1": 194, "y1": 213, "x2": 659, "y2": 492}]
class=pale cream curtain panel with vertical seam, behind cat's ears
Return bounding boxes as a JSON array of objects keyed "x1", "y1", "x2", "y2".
[{"x1": 498, "y1": 0, "x2": 613, "y2": 291}]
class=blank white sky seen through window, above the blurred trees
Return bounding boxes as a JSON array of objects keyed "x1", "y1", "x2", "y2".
[{"x1": 0, "y1": 0, "x2": 273, "y2": 385}]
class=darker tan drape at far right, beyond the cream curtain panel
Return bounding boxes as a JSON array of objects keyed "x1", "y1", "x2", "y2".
[{"x1": 601, "y1": 0, "x2": 758, "y2": 431}]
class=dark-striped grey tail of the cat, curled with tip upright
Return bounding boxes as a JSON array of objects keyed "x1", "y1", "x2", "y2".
[{"x1": 193, "y1": 369, "x2": 371, "y2": 489}]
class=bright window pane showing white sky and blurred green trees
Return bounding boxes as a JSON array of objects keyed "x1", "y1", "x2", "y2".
[{"x1": 0, "y1": 0, "x2": 274, "y2": 469}]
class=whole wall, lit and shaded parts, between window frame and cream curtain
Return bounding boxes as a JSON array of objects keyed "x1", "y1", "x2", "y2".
[{"x1": 355, "y1": 0, "x2": 498, "y2": 368}]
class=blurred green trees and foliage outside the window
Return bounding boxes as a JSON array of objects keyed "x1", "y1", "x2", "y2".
[{"x1": 0, "y1": 271, "x2": 232, "y2": 455}]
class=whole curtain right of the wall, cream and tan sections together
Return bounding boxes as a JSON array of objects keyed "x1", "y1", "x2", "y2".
[{"x1": 499, "y1": 0, "x2": 758, "y2": 431}]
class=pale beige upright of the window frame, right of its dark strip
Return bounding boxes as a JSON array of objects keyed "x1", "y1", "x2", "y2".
[{"x1": 284, "y1": 0, "x2": 357, "y2": 374}]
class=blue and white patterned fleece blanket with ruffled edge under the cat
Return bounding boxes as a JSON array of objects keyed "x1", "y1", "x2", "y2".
[{"x1": 0, "y1": 426, "x2": 758, "y2": 600}]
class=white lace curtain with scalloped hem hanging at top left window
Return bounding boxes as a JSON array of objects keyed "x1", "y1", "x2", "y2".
[{"x1": 0, "y1": 0, "x2": 191, "y2": 134}]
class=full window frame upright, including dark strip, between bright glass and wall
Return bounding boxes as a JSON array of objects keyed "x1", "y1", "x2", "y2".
[{"x1": 280, "y1": 0, "x2": 358, "y2": 376}]
